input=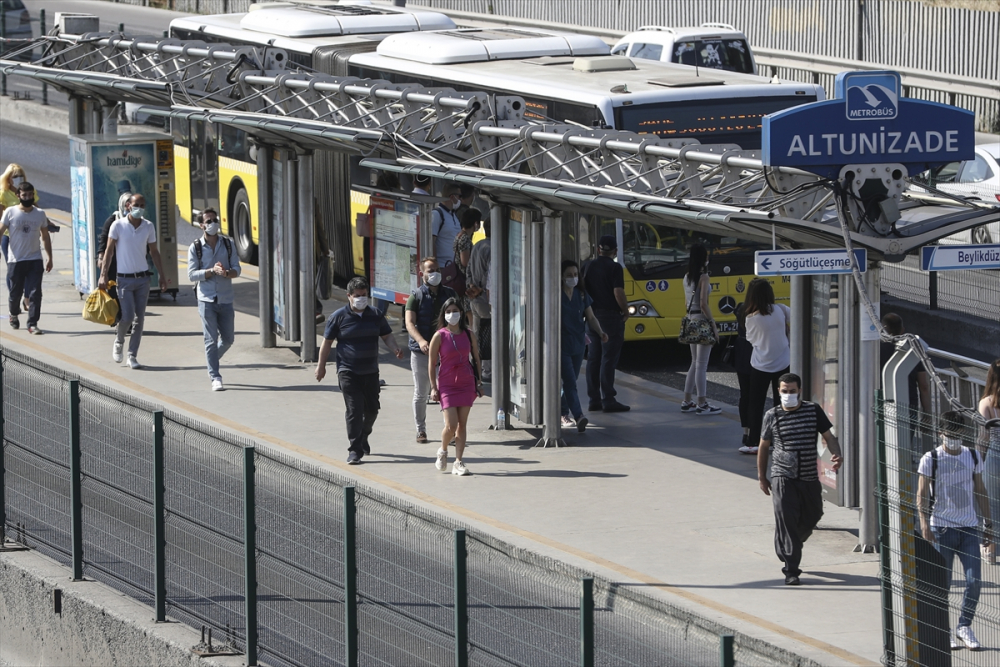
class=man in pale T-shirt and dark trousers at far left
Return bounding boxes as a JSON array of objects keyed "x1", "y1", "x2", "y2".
[{"x1": 0, "y1": 182, "x2": 52, "y2": 334}]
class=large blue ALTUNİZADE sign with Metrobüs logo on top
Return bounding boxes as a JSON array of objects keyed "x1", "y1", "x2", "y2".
[{"x1": 763, "y1": 72, "x2": 975, "y2": 178}]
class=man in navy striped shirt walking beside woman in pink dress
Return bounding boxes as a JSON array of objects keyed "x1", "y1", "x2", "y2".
[{"x1": 316, "y1": 277, "x2": 403, "y2": 465}]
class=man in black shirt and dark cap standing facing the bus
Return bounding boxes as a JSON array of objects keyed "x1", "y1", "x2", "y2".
[{"x1": 583, "y1": 235, "x2": 629, "y2": 412}]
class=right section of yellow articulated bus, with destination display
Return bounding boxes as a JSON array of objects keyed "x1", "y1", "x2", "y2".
[{"x1": 348, "y1": 28, "x2": 808, "y2": 341}]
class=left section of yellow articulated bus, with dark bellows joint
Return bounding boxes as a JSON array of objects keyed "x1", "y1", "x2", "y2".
[{"x1": 170, "y1": 3, "x2": 455, "y2": 281}]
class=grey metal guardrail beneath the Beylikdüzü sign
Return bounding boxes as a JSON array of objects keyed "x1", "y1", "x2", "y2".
[{"x1": 880, "y1": 255, "x2": 1000, "y2": 322}]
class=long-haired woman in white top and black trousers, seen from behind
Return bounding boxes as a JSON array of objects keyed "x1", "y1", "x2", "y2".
[{"x1": 743, "y1": 278, "x2": 792, "y2": 445}]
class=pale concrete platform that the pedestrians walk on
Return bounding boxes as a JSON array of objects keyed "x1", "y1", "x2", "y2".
[{"x1": 0, "y1": 211, "x2": 882, "y2": 665}]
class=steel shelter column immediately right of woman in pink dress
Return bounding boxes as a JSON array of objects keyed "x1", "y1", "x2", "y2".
[{"x1": 489, "y1": 201, "x2": 510, "y2": 429}]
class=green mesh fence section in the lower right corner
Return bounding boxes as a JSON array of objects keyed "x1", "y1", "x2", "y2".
[{"x1": 875, "y1": 396, "x2": 1000, "y2": 667}]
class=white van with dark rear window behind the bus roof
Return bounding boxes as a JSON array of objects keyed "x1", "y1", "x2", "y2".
[{"x1": 611, "y1": 23, "x2": 757, "y2": 74}]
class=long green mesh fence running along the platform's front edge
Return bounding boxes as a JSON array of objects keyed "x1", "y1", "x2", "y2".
[{"x1": 0, "y1": 347, "x2": 776, "y2": 667}]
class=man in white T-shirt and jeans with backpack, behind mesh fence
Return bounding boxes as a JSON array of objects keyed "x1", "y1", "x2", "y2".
[{"x1": 917, "y1": 412, "x2": 997, "y2": 651}]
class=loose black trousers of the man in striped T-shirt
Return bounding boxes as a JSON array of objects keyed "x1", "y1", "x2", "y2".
[{"x1": 771, "y1": 477, "x2": 823, "y2": 577}]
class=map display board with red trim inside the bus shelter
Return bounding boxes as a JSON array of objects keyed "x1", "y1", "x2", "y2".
[{"x1": 371, "y1": 196, "x2": 420, "y2": 303}]
